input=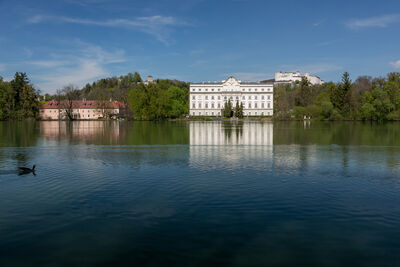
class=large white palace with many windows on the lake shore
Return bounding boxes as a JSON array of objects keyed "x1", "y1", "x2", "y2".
[{"x1": 189, "y1": 77, "x2": 274, "y2": 116}]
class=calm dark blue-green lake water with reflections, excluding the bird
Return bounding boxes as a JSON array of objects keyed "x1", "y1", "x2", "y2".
[{"x1": 0, "y1": 122, "x2": 400, "y2": 266}]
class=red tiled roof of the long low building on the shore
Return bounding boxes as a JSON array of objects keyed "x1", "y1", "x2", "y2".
[{"x1": 41, "y1": 100, "x2": 126, "y2": 109}]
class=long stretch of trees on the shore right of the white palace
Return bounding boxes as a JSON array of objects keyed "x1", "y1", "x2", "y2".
[{"x1": 274, "y1": 72, "x2": 400, "y2": 121}]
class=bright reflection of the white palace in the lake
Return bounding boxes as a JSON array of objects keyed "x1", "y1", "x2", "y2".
[{"x1": 189, "y1": 122, "x2": 273, "y2": 169}]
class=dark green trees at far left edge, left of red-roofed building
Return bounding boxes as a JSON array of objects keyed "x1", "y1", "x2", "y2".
[{"x1": 0, "y1": 72, "x2": 40, "y2": 120}]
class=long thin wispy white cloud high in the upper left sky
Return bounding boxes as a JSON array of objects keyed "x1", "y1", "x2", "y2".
[{"x1": 27, "y1": 15, "x2": 189, "y2": 44}]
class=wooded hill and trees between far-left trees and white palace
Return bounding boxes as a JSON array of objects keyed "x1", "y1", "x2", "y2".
[{"x1": 45, "y1": 72, "x2": 189, "y2": 120}]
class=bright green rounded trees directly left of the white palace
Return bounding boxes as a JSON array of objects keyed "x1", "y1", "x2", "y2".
[{"x1": 128, "y1": 80, "x2": 189, "y2": 120}]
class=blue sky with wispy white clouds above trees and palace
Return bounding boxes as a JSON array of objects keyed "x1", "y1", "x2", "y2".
[{"x1": 0, "y1": 0, "x2": 400, "y2": 93}]
